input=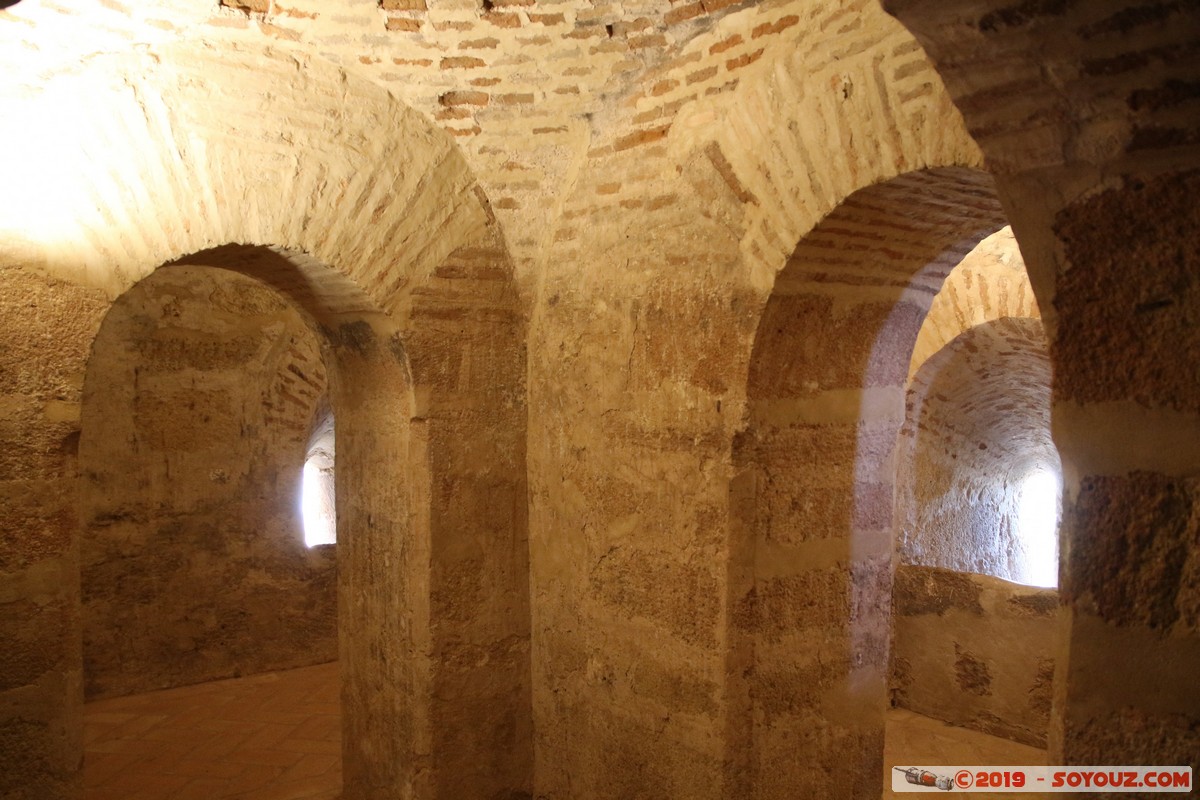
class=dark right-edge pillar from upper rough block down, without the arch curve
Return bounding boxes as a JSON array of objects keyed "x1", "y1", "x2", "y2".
[{"x1": 1054, "y1": 172, "x2": 1200, "y2": 770}]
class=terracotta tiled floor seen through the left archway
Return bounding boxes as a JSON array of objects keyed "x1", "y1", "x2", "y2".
[{"x1": 83, "y1": 663, "x2": 342, "y2": 800}]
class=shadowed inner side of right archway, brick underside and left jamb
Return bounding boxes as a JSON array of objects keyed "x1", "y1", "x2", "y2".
[{"x1": 730, "y1": 168, "x2": 1003, "y2": 799}]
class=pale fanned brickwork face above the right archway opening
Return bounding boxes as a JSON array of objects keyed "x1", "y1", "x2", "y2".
[{"x1": 678, "y1": 0, "x2": 984, "y2": 294}]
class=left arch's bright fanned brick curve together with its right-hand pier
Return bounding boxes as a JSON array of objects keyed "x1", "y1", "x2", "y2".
[{"x1": 2, "y1": 42, "x2": 532, "y2": 798}]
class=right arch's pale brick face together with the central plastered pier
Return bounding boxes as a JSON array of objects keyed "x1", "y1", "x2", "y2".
[{"x1": 530, "y1": 2, "x2": 1002, "y2": 798}]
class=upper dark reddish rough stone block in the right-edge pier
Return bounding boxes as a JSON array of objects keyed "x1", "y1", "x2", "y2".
[{"x1": 1055, "y1": 172, "x2": 1200, "y2": 414}]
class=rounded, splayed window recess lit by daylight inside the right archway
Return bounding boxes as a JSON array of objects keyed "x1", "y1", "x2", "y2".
[{"x1": 896, "y1": 318, "x2": 1061, "y2": 585}]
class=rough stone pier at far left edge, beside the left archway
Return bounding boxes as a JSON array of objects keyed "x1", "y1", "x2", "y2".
[{"x1": 0, "y1": 267, "x2": 104, "y2": 800}]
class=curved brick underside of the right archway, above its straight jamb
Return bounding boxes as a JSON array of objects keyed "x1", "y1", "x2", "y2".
[{"x1": 748, "y1": 167, "x2": 1006, "y2": 402}]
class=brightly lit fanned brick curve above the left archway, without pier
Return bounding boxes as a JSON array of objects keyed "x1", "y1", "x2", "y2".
[{"x1": 6, "y1": 42, "x2": 501, "y2": 315}]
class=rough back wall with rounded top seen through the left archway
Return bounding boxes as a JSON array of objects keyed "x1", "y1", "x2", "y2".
[{"x1": 79, "y1": 266, "x2": 337, "y2": 697}]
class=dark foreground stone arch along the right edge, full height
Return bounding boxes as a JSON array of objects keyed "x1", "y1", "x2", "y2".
[{"x1": 883, "y1": 0, "x2": 1200, "y2": 769}]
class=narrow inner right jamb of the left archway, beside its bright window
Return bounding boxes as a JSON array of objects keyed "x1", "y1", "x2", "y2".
[{"x1": 328, "y1": 320, "x2": 430, "y2": 800}]
